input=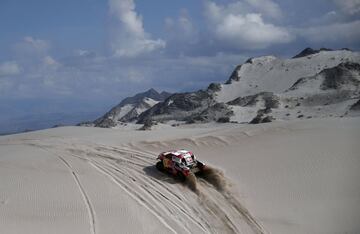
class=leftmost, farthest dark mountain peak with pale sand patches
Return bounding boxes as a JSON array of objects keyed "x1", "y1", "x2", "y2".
[{"x1": 84, "y1": 89, "x2": 171, "y2": 128}]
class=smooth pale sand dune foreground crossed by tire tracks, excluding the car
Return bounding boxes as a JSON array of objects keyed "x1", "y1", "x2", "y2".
[{"x1": 0, "y1": 118, "x2": 360, "y2": 234}]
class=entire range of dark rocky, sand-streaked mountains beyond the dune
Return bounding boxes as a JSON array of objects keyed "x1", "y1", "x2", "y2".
[{"x1": 81, "y1": 48, "x2": 360, "y2": 128}]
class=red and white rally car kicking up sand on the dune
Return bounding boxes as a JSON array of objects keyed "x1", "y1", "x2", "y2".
[{"x1": 156, "y1": 150, "x2": 205, "y2": 179}]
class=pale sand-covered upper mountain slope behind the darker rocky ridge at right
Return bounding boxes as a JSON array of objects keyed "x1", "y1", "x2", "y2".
[{"x1": 216, "y1": 50, "x2": 360, "y2": 103}]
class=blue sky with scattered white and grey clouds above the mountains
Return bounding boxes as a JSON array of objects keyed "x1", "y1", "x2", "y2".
[{"x1": 0, "y1": 0, "x2": 360, "y2": 132}]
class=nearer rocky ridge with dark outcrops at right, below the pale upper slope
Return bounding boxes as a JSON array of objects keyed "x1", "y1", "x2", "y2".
[{"x1": 227, "y1": 62, "x2": 360, "y2": 123}]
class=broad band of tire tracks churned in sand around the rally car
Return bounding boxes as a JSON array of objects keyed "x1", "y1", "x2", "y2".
[{"x1": 33, "y1": 141, "x2": 266, "y2": 234}]
